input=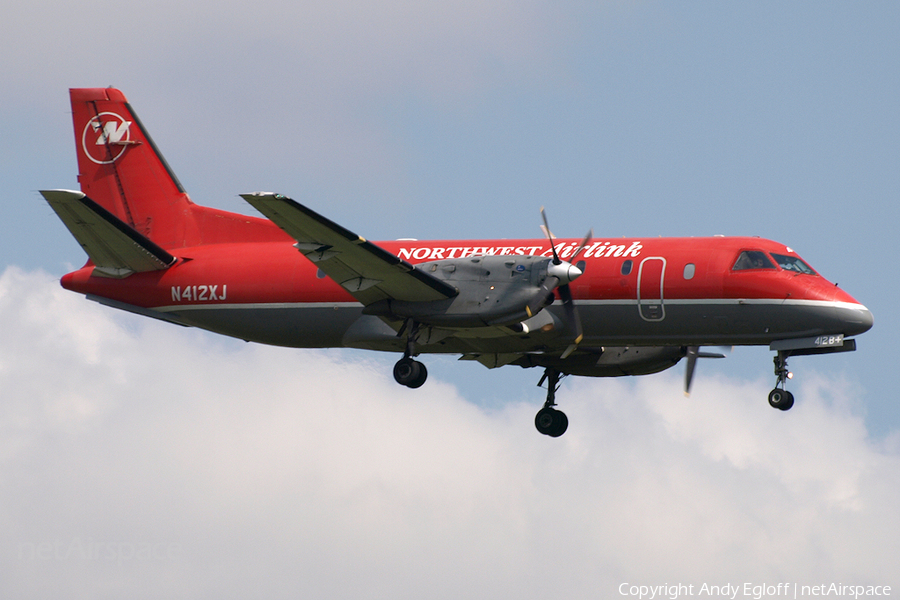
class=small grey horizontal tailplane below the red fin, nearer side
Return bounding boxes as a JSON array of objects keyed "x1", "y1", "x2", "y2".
[{"x1": 41, "y1": 190, "x2": 175, "y2": 278}]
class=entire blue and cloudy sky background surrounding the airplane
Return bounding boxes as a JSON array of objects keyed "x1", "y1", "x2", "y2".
[{"x1": 0, "y1": 0, "x2": 900, "y2": 599}]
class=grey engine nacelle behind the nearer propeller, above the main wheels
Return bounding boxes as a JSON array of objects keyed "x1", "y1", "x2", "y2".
[{"x1": 363, "y1": 255, "x2": 560, "y2": 327}]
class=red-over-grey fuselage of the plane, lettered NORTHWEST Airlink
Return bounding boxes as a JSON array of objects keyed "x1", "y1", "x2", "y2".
[{"x1": 62, "y1": 227, "x2": 872, "y2": 352}]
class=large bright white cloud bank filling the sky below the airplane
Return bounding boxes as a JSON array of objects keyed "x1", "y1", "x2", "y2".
[{"x1": 0, "y1": 267, "x2": 900, "y2": 598}]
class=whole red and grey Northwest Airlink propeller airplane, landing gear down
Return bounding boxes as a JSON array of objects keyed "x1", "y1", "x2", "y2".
[{"x1": 41, "y1": 88, "x2": 873, "y2": 437}]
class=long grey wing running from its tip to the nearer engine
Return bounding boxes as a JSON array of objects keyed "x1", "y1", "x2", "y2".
[{"x1": 241, "y1": 192, "x2": 458, "y2": 305}]
